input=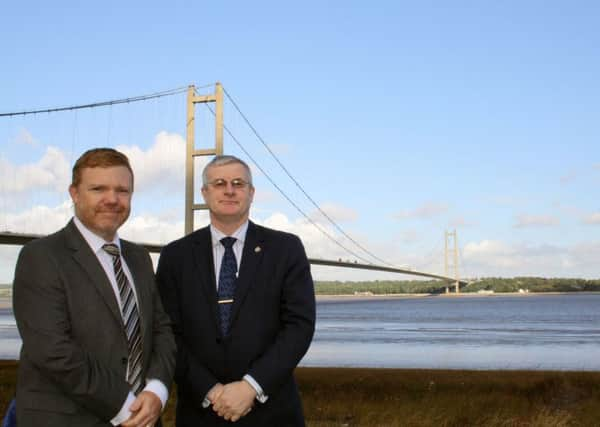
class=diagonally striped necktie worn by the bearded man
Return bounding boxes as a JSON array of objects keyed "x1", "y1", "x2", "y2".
[{"x1": 102, "y1": 243, "x2": 144, "y2": 395}]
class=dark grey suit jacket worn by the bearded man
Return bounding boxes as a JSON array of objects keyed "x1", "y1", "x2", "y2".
[{"x1": 13, "y1": 221, "x2": 175, "y2": 427}]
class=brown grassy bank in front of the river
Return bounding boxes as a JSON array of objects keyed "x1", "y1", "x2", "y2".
[{"x1": 0, "y1": 362, "x2": 600, "y2": 427}]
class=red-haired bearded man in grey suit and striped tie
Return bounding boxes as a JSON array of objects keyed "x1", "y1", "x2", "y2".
[{"x1": 13, "y1": 148, "x2": 175, "y2": 427}]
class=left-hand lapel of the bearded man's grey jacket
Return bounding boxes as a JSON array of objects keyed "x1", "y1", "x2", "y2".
[{"x1": 65, "y1": 220, "x2": 123, "y2": 325}]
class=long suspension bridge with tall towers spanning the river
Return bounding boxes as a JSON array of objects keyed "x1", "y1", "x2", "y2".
[{"x1": 0, "y1": 83, "x2": 467, "y2": 292}]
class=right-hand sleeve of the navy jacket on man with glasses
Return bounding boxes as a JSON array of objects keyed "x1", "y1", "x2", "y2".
[{"x1": 248, "y1": 235, "x2": 316, "y2": 395}]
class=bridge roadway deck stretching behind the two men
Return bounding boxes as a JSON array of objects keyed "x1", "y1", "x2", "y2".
[{"x1": 0, "y1": 232, "x2": 467, "y2": 286}]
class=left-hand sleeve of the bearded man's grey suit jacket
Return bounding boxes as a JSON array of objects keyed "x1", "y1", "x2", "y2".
[{"x1": 13, "y1": 242, "x2": 130, "y2": 421}]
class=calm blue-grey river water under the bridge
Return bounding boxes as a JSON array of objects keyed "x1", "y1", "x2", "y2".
[{"x1": 0, "y1": 293, "x2": 600, "y2": 371}]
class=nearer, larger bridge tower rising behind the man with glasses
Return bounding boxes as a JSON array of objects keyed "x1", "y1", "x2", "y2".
[{"x1": 185, "y1": 82, "x2": 223, "y2": 235}]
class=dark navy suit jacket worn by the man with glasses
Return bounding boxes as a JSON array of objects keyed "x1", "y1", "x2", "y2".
[{"x1": 157, "y1": 222, "x2": 315, "y2": 427}]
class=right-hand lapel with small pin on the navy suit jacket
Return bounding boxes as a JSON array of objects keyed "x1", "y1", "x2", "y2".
[{"x1": 231, "y1": 221, "x2": 264, "y2": 324}]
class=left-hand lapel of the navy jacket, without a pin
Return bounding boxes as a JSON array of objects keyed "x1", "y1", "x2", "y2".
[{"x1": 192, "y1": 227, "x2": 219, "y2": 331}]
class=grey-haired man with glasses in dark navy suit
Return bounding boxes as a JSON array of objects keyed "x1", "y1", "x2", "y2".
[{"x1": 157, "y1": 156, "x2": 315, "y2": 427}]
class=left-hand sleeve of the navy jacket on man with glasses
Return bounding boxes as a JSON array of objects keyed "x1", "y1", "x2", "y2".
[{"x1": 156, "y1": 246, "x2": 218, "y2": 408}]
